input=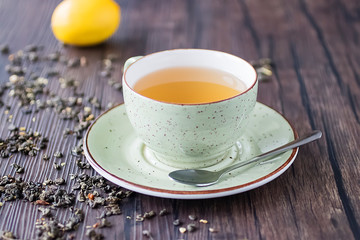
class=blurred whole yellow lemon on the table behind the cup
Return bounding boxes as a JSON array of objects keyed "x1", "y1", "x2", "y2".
[{"x1": 51, "y1": 0, "x2": 121, "y2": 46}]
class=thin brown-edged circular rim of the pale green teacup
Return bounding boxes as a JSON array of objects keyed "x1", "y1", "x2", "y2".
[{"x1": 123, "y1": 48, "x2": 258, "y2": 106}]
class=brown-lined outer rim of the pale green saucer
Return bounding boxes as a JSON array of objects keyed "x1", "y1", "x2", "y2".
[{"x1": 83, "y1": 101, "x2": 299, "y2": 199}]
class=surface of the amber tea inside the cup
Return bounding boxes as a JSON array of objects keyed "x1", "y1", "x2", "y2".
[{"x1": 134, "y1": 67, "x2": 246, "y2": 104}]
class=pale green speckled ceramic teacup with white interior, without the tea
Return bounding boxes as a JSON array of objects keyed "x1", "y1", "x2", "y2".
[{"x1": 123, "y1": 49, "x2": 258, "y2": 168}]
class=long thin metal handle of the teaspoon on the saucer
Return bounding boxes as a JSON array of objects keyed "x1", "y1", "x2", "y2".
[{"x1": 219, "y1": 130, "x2": 322, "y2": 175}]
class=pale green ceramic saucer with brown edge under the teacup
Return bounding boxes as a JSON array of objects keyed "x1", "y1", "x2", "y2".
[{"x1": 84, "y1": 102, "x2": 298, "y2": 199}]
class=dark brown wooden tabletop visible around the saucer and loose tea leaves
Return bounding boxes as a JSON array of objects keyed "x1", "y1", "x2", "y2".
[{"x1": 0, "y1": 0, "x2": 360, "y2": 240}]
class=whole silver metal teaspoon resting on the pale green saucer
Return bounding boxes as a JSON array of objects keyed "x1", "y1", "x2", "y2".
[{"x1": 169, "y1": 130, "x2": 322, "y2": 187}]
